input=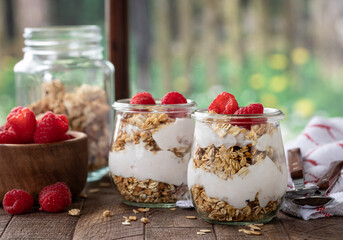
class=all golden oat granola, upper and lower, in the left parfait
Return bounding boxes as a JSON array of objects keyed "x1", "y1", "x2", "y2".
[{"x1": 111, "y1": 112, "x2": 191, "y2": 203}]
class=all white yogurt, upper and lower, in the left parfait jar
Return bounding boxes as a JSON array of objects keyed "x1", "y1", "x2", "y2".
[{"x1": 109, "y1": 118, "x2": 194, "y2": 185}]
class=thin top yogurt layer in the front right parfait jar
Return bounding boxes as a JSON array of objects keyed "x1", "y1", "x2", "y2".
[{"x1": 194, "y1": 122, "x2": 283, "y2": 151}]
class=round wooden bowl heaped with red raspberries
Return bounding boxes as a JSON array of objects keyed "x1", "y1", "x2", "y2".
[{"x1": 0, "y1": 107, "x2": 88, "y2": 202}]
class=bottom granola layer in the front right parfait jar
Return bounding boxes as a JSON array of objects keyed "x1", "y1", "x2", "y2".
[{"x1": 191, "y1": 185, "x2": 281, "y2": 222}]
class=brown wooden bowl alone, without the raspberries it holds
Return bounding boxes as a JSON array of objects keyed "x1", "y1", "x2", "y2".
[{"x1": 0, "y1": 131, "x2": 88, "y2": 201}]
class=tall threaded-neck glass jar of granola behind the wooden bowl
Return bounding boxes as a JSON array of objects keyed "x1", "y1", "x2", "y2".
[{"x1": 14, "y1": 26, "x2": 114, "y2": 178}]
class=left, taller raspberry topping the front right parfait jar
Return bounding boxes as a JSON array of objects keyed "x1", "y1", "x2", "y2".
[{"x1": 208, "y1": 92, "x2": 239, "y2": 114}]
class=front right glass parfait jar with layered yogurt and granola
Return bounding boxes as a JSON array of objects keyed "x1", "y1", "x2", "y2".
[{"x1": 188, "y1": 108, "x2": 287, "y2": 225}]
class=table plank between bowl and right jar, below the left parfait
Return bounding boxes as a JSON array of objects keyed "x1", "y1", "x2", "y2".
[{"x1": 74, "y1": 179, "x2": 144, "y2": 240}]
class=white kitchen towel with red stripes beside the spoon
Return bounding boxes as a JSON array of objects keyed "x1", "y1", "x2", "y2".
[{"x1": 282, "y1": 117, "x2": 343, "y2": 220}]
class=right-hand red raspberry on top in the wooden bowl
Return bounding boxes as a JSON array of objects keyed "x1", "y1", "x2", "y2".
[{"x1": 33, "y1": 112, "x2": 68, "y2": 143}]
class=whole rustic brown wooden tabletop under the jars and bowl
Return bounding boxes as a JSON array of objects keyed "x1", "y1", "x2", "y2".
[{"x1": 0, "y1": 175, "x2": 343, "y2": 240}]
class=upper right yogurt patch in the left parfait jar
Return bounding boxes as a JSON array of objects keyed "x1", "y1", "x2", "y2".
[{"x1": 152, "y1": 118, "x2": 194, "y2": 149}]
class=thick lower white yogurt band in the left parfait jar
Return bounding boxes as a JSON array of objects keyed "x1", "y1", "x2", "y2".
[{"x1": 109, "y1": 144, "x2": 190, "y2": 186}]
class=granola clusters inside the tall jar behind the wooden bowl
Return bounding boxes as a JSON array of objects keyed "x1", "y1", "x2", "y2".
[{"x1": 28, "y1": 80, "x2": 110, "y2": 171}]
